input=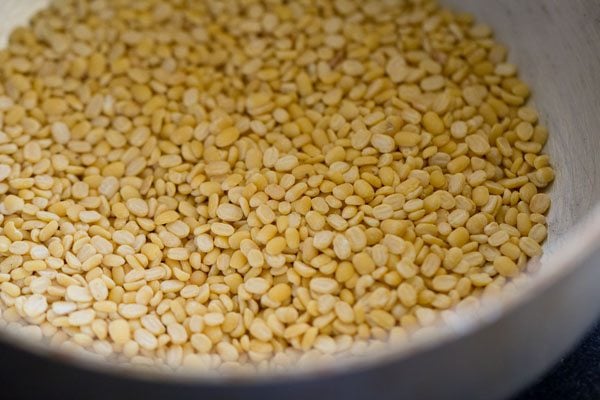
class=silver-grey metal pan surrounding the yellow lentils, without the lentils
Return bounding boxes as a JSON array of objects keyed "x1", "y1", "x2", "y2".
[{"x1": 0, "y1": 0, "x2": 600, "y2": 400}]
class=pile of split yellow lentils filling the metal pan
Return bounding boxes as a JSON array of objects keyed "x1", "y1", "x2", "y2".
[{"x1": 0, "y1": 0, "x2": 554, "y2": 369}]
